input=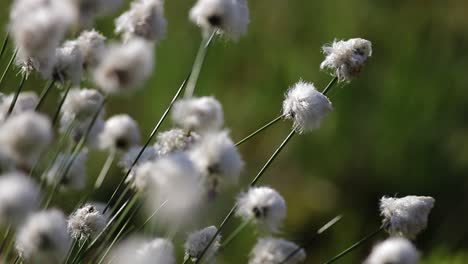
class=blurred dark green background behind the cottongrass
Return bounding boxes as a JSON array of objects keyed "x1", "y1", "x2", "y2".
[{"x1": 0, "y1": 0, "x2": 468, "y2": 264}]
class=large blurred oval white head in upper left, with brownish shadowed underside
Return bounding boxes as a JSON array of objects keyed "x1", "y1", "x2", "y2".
[{"x1": 94, "y1": 38, "x2": 155, "y2": 94}]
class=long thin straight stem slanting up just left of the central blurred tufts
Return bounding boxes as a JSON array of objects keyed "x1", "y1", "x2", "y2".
[{"x1": 104, "y1": 72, "x2": 192, "y2": 213}]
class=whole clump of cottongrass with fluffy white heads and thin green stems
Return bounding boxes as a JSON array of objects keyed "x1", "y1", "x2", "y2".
[{"x1": 0, "y1": 0, "x2": 434, "y2": 264}]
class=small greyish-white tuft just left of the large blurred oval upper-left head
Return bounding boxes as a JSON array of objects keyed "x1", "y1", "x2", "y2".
[{"x1": 52, "y1": 40, "x2": 83, "y2": 85}]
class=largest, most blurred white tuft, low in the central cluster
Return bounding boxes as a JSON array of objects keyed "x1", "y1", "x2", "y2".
[{"x1": 143, "y1": 152, "x2": 202, "y2": 223}]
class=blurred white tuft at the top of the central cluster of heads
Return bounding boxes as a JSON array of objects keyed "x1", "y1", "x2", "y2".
[{"x1": 172, "y1": 96, "x2": 224, "y2": 133}]
